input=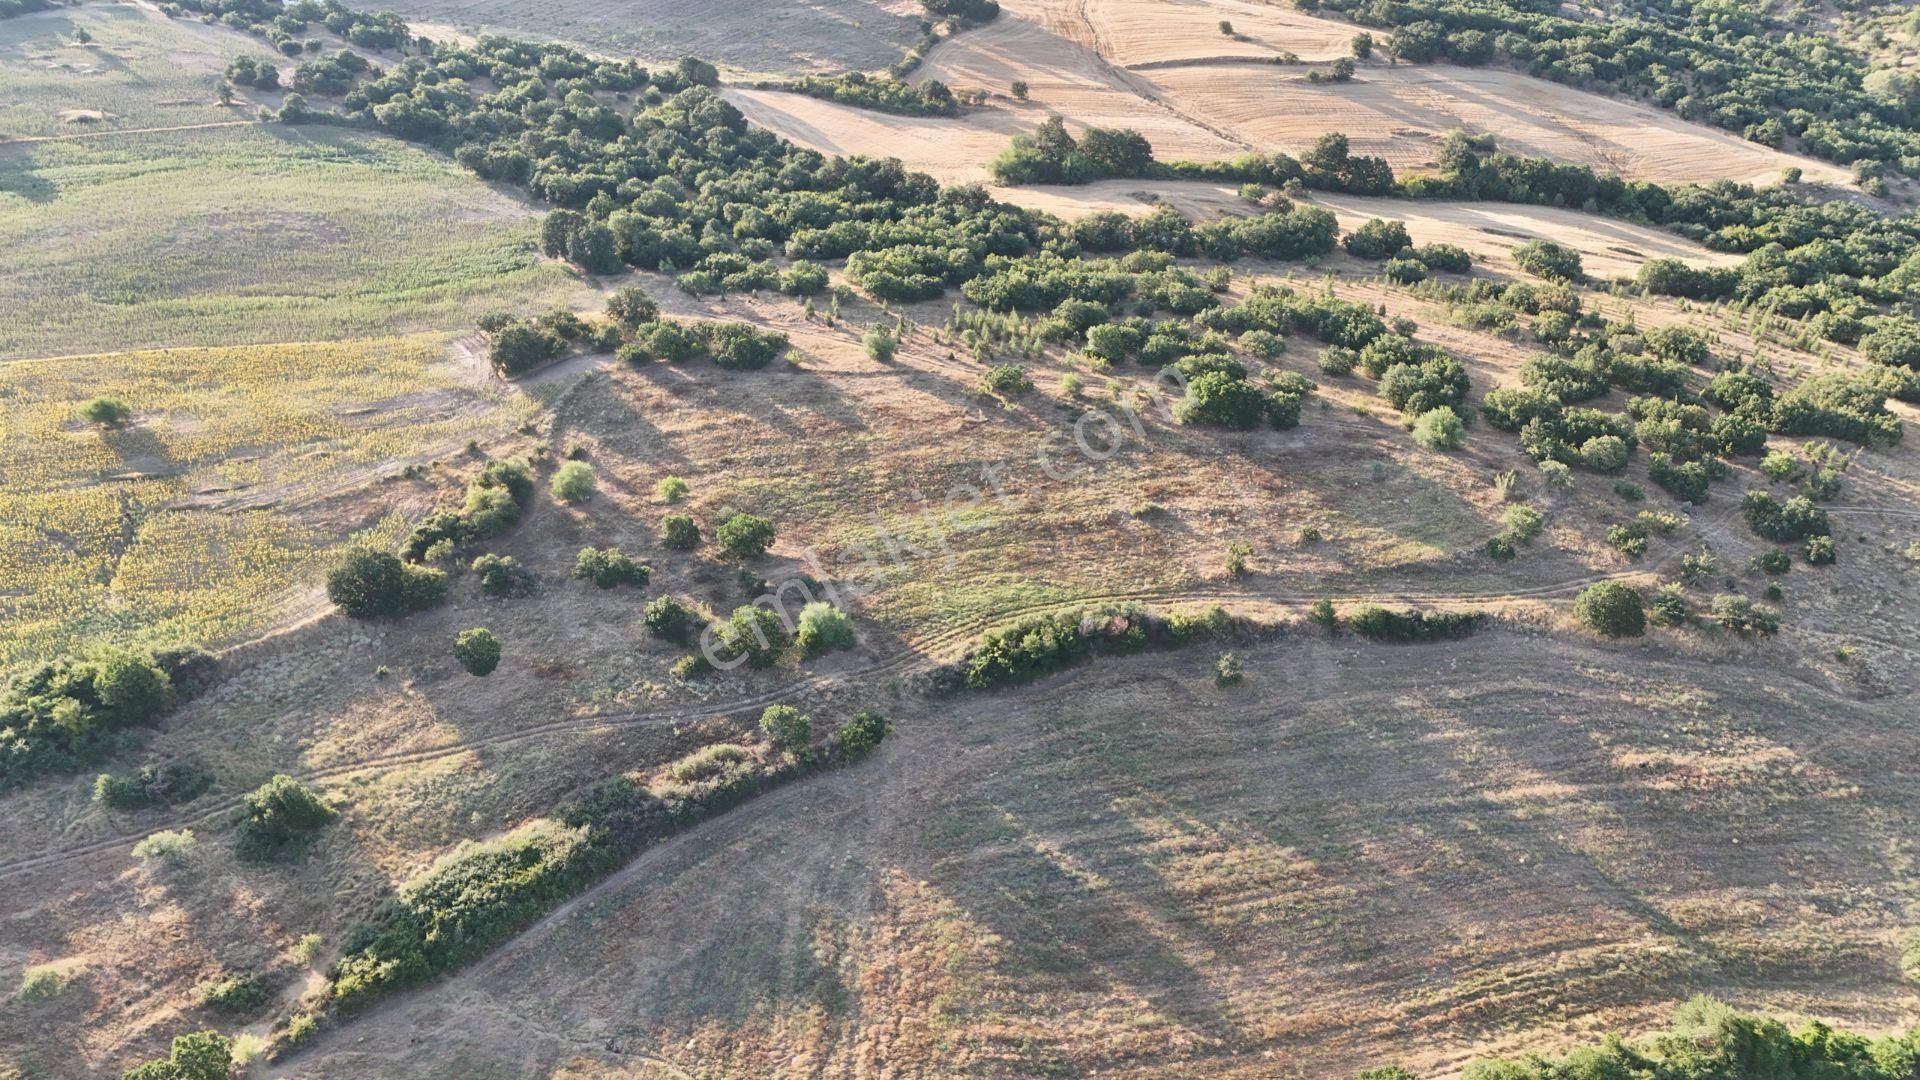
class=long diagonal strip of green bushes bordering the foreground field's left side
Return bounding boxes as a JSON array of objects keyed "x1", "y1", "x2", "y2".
[{"x1": 330, "y1": 713, "x2": 889, "y2": 1009}]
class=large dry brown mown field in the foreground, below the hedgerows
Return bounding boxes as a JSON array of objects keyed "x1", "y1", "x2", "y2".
[{"x1": 263, "y1": 632, "x2": 1920, "y2": 1078}]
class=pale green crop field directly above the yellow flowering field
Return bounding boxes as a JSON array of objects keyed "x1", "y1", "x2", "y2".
[{"x1": 0, "y1": 125, "x2": 586, "y2": 357}]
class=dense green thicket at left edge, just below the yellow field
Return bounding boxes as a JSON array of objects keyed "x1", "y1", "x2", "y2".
[{"x1": 0, "y1": 650, "x2": 191, "y2": 784}]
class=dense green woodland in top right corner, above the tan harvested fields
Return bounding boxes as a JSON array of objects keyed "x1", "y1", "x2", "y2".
[{"x1": 1315, "y1": 0, "x2": 1920, "y2": 175}]
